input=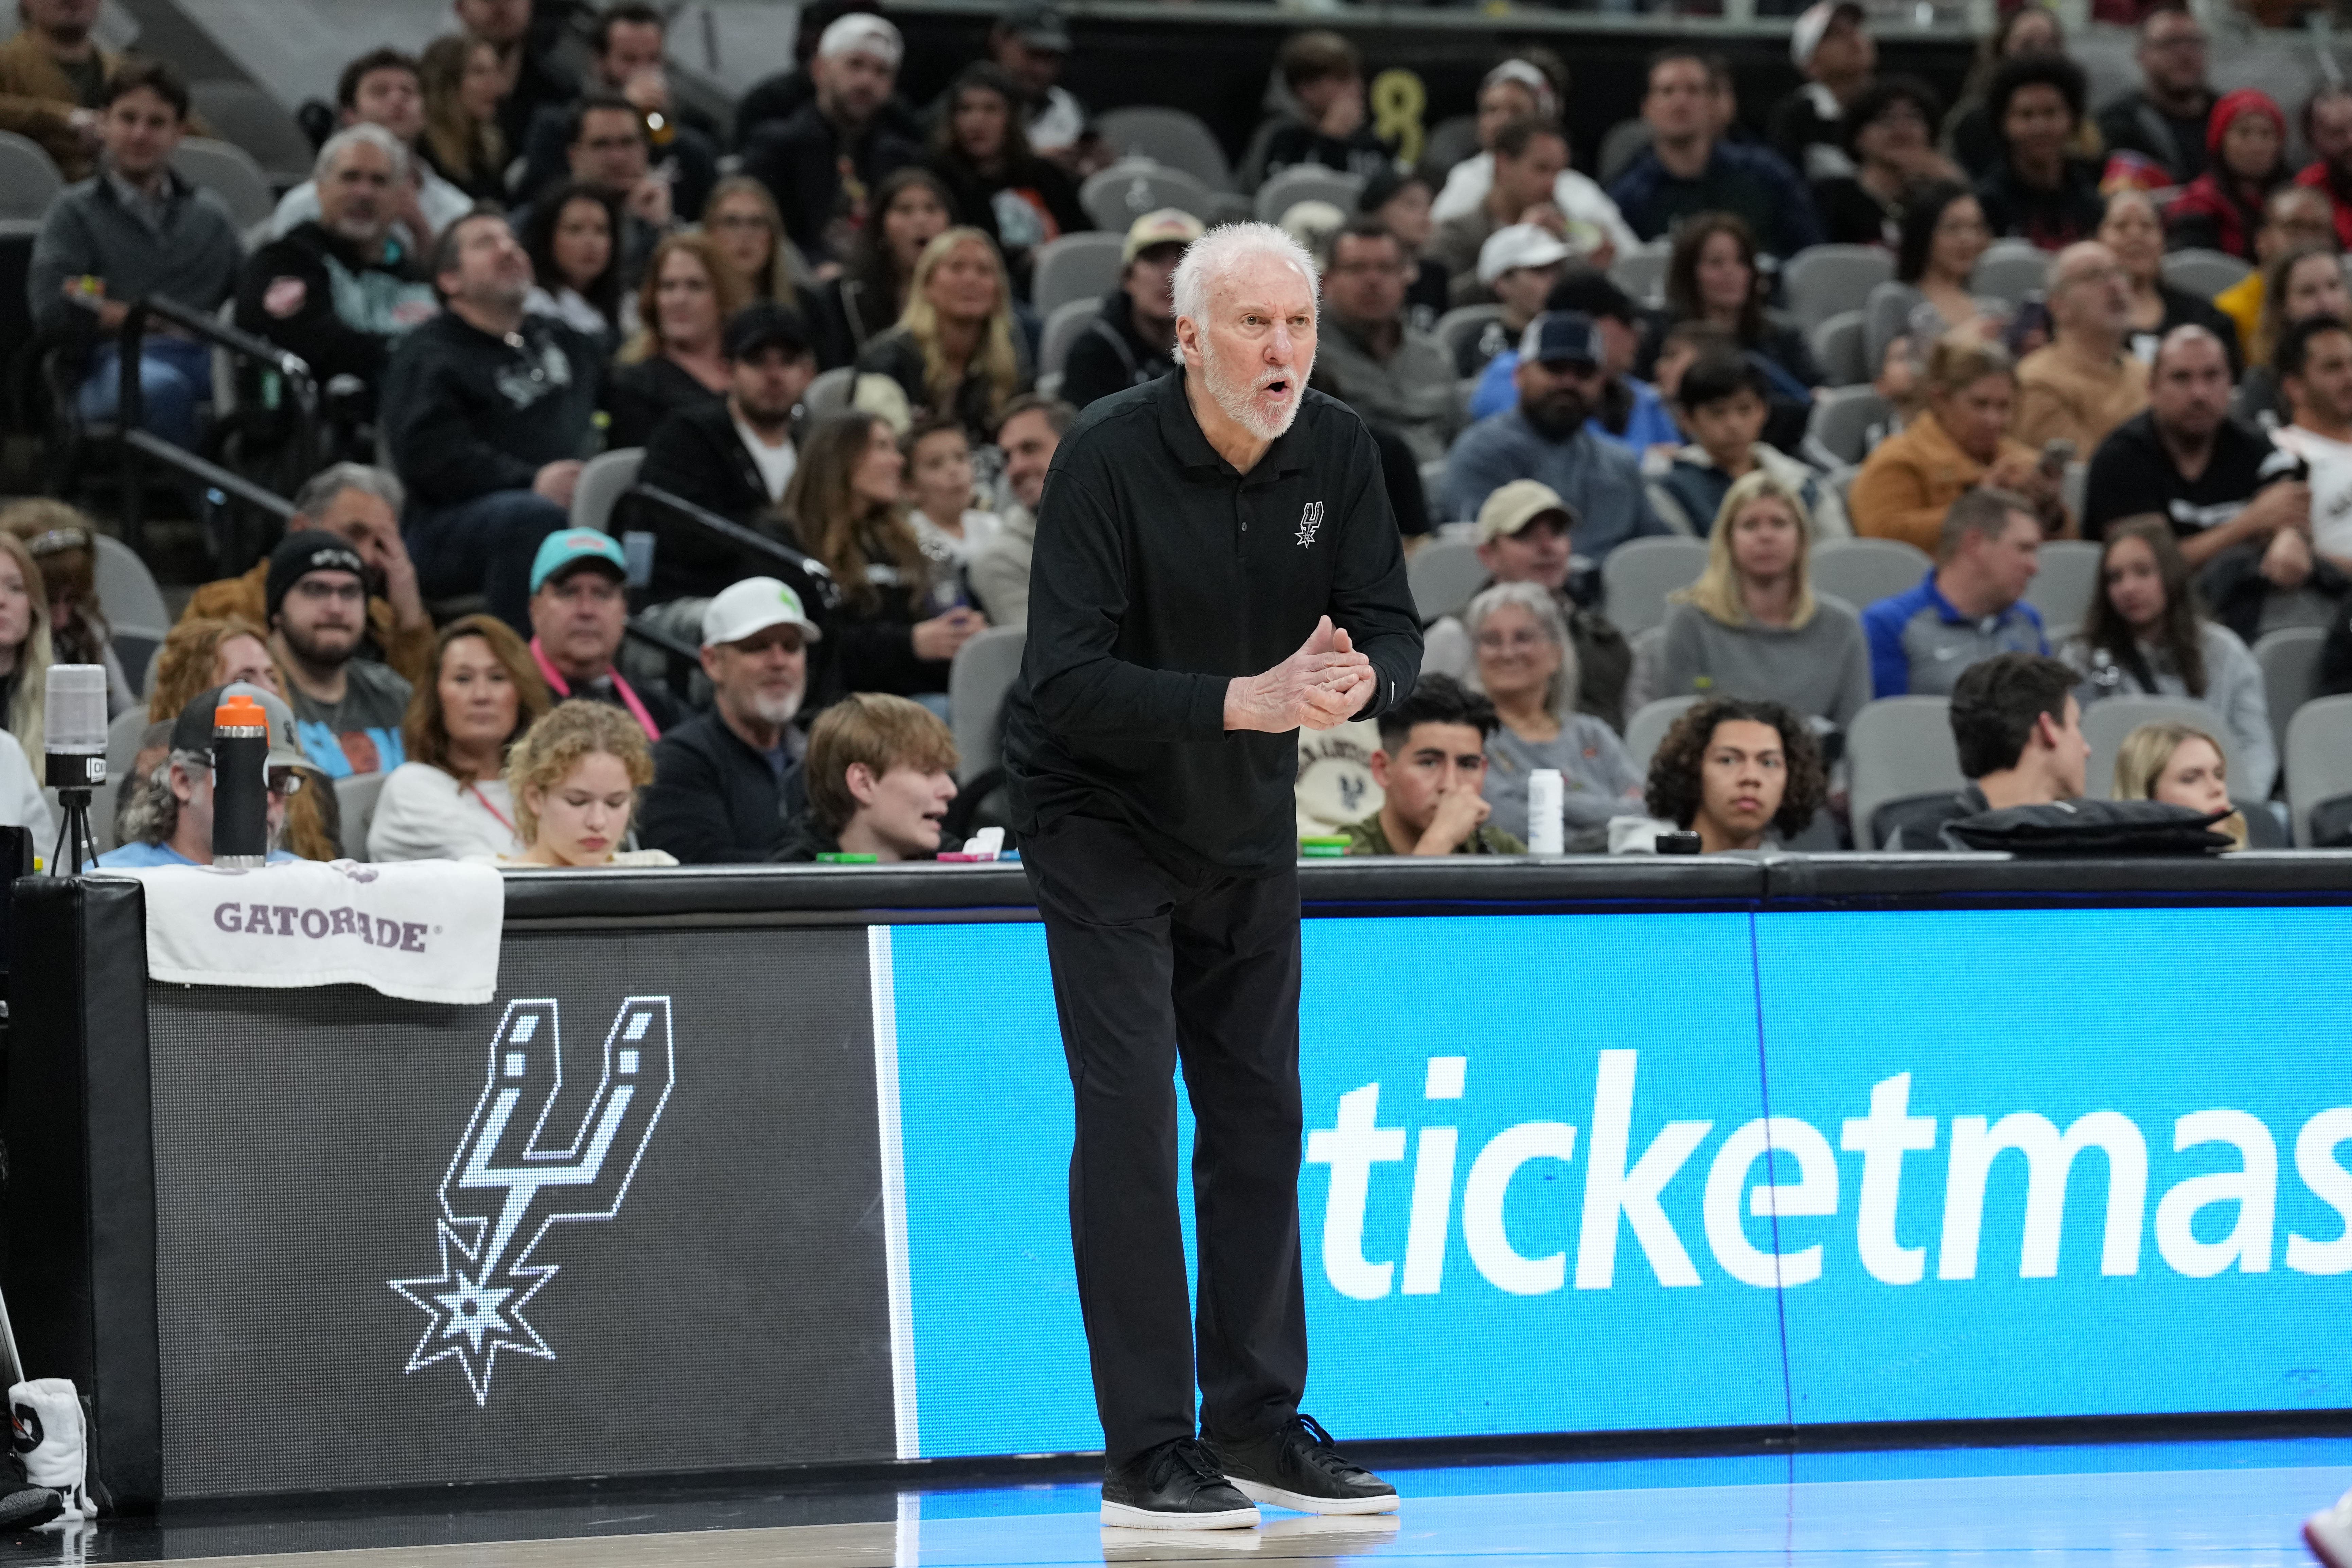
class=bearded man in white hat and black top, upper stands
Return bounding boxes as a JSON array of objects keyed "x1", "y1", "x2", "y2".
[{"x1": 743, "y1": 12, "x2": 922, "y2": 266}]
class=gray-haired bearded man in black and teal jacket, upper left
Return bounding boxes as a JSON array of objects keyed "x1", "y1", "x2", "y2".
[{"x1": 237, "y1": 120, "x2": 440, "y2": 411}]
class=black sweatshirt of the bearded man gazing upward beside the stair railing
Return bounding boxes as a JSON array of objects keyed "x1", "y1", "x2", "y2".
[{"x1": 383, "y1": 310, "x2": 604, "y2": 506}]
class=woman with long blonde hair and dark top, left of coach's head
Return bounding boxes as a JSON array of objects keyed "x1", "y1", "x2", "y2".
[{"x1": 856, "y1": 228, "x2": 1035, "y2": 444}]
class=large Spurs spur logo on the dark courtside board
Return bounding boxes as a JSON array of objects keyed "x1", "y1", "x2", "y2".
[{"x1": 386, "y1": 997, "x2": 677, "y2": 1406}]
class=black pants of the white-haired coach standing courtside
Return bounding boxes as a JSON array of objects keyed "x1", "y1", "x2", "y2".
[{"x1": 1021, "y1": 816, "x2": 1308, "y2": 1465}]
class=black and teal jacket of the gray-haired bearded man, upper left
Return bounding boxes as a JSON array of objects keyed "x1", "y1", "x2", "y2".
[{"x1": 237, "y1": 223, "x2": 440, "y2": 413}]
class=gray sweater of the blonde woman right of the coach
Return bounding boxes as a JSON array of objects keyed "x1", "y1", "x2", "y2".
[{"x1": 1651, "y1": 595, "x2": 1870, "y2": 729}]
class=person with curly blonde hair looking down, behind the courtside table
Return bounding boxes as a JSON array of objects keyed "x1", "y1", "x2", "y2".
[{"x1": 496, "y1": 701, "x2": 677, "y2": 867}]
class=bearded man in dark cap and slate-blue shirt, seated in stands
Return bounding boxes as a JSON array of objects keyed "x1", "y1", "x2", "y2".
[{"x1": 1444, "y1": 310, "x2": 1670, "y2": 562}]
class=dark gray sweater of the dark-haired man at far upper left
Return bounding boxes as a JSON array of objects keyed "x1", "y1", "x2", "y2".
[{"x1": 23, "y1": 174, "x2": 245, "y2": 338}]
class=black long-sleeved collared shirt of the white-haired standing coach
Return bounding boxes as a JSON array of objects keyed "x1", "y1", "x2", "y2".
[{"x1": 1004, "y1": 371, "x2": 1420, "y2": 872}]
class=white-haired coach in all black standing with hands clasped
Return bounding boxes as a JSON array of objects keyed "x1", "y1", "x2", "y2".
[{"x1": 1004, "y1": 223, "x2": 1420, "y2": 1528}]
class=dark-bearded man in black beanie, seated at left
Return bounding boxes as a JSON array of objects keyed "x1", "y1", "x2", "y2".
[{"x1": 268, "y1": 534, "x2": 409, "y2": 778}]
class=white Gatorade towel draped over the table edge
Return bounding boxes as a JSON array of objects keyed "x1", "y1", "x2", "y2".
[{"x1": 110, "y1": 860, "x2": 506, "y2": 1002}]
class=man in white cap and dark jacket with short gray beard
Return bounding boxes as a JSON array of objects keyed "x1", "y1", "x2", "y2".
[{"x1": 637, "y1": 576, "x2": 826, "y2": 865}]
